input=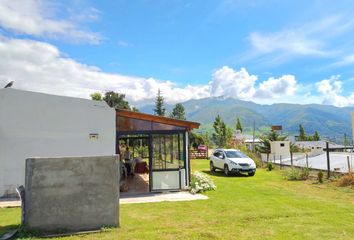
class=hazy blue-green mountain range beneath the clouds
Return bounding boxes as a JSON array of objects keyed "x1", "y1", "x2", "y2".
[{"x1": 139, "y1": 97, "x2": 354, "y2": 142}]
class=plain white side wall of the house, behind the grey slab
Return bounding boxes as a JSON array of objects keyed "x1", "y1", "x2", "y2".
[{"x1": 0, "y1": 89, "x2": 116, "y2": 197}]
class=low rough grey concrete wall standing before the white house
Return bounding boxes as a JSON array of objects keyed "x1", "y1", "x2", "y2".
[{"x1": 24, "y1": 156, "x2": 119, "y2": 232}]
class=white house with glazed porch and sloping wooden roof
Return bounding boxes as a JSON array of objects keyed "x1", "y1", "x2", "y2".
[{"x1": 0, "y1": 88, "x2": 199, "y2": 197}]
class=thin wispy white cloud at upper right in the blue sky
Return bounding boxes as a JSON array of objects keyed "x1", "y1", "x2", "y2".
[{"x1": 248, "y1": 15, "x2": 354, "y2": 62}]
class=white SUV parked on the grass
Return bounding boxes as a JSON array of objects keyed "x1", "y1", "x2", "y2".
[{"x1": 210, "y1": 149, "x2": 256, "y2": 176}]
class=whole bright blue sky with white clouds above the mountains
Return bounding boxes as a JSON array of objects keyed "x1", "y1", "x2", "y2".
[{"x1": 0, "y1": 0, "x2": 354, "y2": 106}]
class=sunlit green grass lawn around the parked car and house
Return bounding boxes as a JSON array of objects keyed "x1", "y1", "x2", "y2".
[{"x1": 0, "y1": 160, "x2": 354, "y2": 240}]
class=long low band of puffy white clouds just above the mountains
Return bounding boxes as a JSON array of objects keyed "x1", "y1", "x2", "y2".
[{"x1": 0, "y1": 36, "x2": 354, "y2": 106}]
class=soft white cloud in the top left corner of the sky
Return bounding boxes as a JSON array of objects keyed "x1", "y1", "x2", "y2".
[{"x1": 0, "y1": 0, "x2": 101, "y2": 44}]
